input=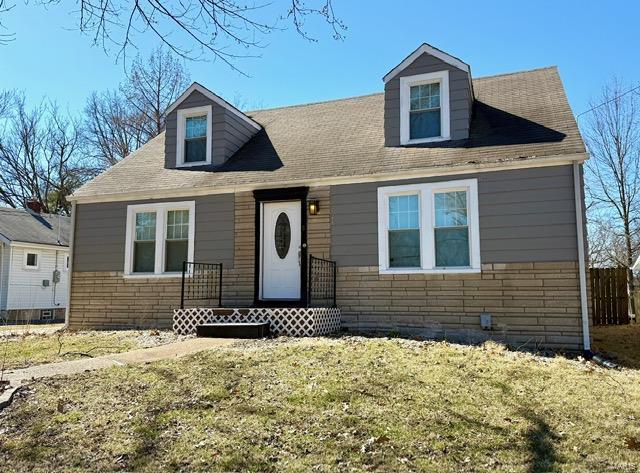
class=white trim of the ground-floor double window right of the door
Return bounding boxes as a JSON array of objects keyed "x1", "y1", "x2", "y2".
[{"x1": 378, "y1": 179, "x2": 481, "y2": 274}]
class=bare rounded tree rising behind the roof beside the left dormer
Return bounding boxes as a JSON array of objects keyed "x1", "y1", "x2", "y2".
[{"x1": 121, "y1": 47, "x2": 189, "y2": 140}]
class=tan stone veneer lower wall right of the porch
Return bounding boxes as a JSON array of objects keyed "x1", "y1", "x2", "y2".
[{"x1": 337, "y1": 262, "x2": 582, "y2": 350}]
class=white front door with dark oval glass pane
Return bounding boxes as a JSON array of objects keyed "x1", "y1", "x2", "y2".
[{"x1": 261, "y1": 200, "x2": 302, "y2": 300}]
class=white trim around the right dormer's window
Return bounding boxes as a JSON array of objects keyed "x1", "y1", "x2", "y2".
[{"x1": 400, "y1": 71, "x2": 451, "y2": 145}]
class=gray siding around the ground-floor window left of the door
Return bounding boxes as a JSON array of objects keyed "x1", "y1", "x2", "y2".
[{"x1": 73, "y1": 194, "x2": 235, "y2": 271}]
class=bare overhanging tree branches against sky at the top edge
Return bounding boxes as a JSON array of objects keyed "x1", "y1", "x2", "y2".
[{"x1": 0, "y1": 0, "x2": 346, "y2": 70}]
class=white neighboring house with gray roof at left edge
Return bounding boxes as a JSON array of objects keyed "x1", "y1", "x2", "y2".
[{"x1": 0, "y1": 202, "x2": 71, "y2": 322}]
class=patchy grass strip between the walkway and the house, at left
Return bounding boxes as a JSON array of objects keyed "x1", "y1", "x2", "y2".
[{"x1": 0, "y1": 330, "x2": 182, "y2": 370}]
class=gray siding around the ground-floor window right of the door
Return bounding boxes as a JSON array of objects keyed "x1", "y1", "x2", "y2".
[{"x1": 331, "y1": 166, "x2": 578, "y2": 266}]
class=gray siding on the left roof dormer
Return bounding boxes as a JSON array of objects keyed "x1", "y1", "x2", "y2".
[{"x1": 164, "y1": 90, "x2": 257, "y2": 169}]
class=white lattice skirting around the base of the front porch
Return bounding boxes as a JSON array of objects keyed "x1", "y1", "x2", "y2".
[{"x1": 173, "y1": 307, "x2": 340, "y2": 337}]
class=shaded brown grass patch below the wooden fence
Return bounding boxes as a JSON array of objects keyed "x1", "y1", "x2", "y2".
[{"x1": 591, "y1": 323, "x2": 640, "y2": 369}]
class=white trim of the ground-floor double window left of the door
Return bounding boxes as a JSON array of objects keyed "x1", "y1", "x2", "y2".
[{"x1": 124, "y1": 200, "x2": 196, "y2": 278}]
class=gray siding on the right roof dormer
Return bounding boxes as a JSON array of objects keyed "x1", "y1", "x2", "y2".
[{"x1": 384, "y1": 53, "x2": 473, "y2": 146}]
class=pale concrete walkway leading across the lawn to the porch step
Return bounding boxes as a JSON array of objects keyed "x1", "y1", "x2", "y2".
[{"x1": 0, "y1": 338, "x2": 237, "y2": 409}]
